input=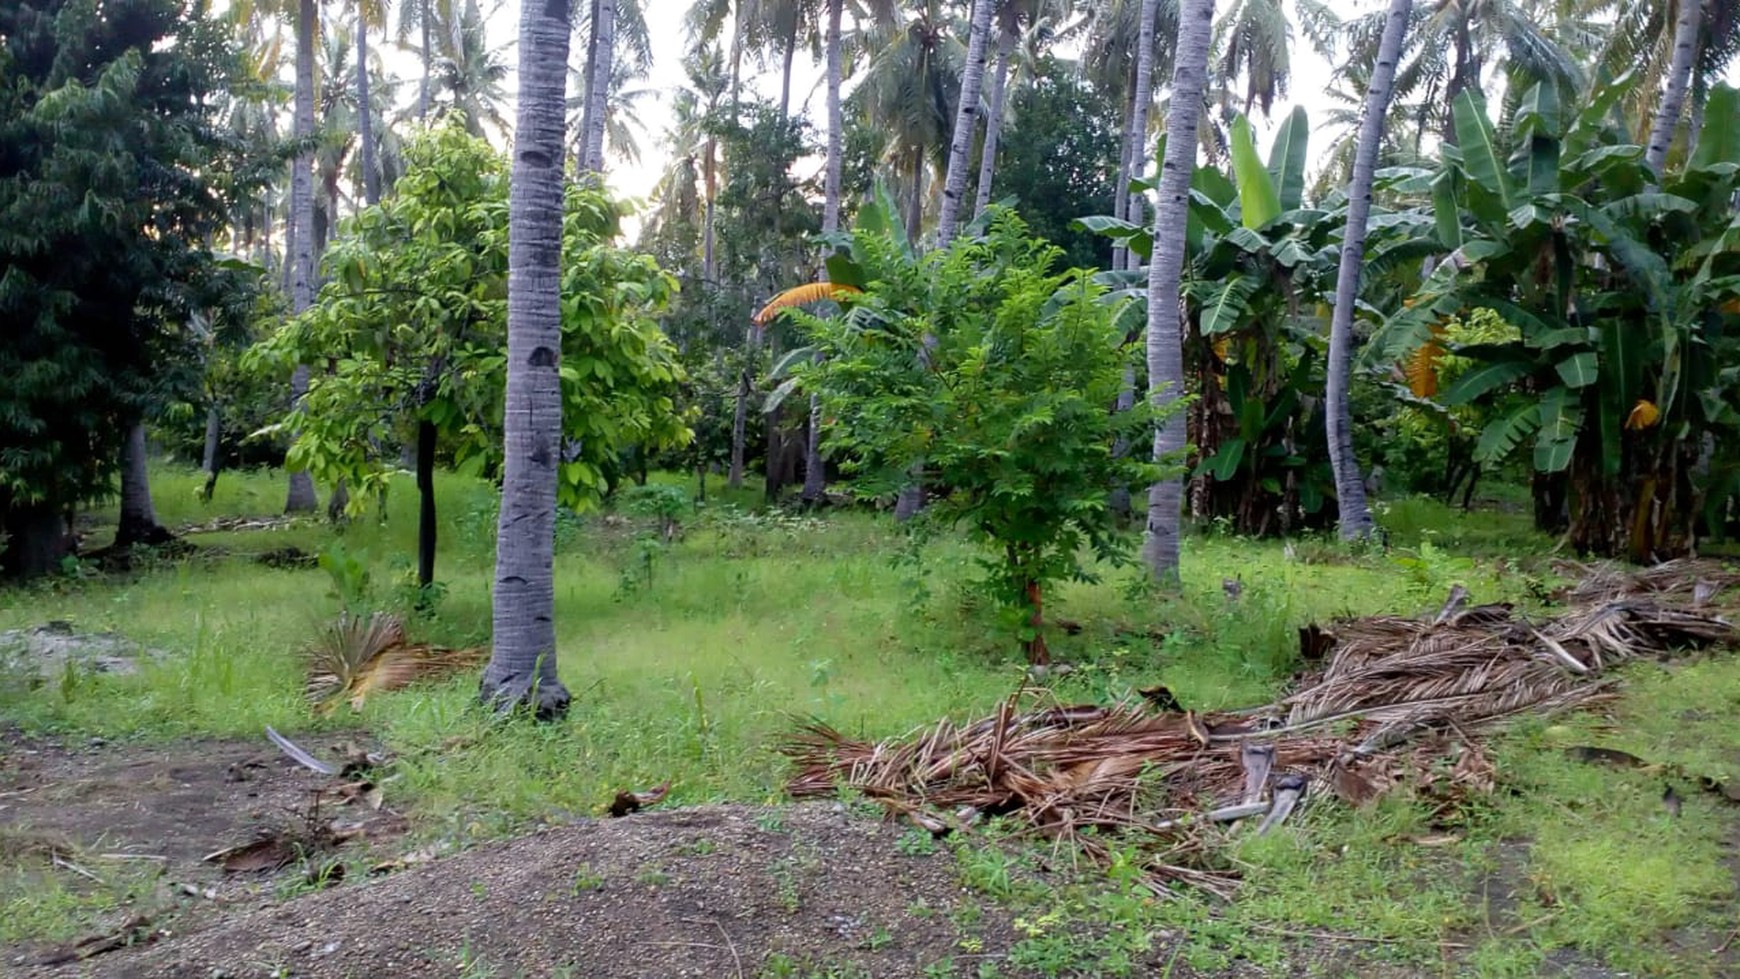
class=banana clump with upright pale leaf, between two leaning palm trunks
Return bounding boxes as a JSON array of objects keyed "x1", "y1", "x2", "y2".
[{"x1": 1079, "y1": 110, "x2": 1430, "y2": 534}]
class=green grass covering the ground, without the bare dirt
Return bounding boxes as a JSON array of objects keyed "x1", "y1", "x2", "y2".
[{"x1": 0, "y1": 471, "x2": 1740, "y2": 976}]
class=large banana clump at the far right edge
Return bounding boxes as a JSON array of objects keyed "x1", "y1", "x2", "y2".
[{"x1": 1369, "y1": 78, "x2": 1740, "y2": 560}]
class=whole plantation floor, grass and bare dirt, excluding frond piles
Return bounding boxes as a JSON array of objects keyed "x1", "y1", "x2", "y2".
[{"x1": 10, "y1": 470, "x2": 1740, "y2": 979}]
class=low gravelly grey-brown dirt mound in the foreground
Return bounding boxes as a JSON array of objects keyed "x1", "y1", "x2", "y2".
[{"x1": 26, "y1": 805, "x2": 1013, "y2": 979}]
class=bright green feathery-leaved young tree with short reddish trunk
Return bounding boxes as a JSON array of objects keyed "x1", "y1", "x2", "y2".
[{"x1": 785, "y1": 206, "x2": 1176, "y2": 663}]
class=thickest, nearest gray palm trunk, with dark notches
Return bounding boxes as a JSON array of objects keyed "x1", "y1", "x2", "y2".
[{"x1": 480, "y1": 0, "x2": 571, "y2": 718}]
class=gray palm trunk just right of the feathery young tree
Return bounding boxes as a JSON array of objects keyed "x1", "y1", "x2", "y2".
[{"x1": 1141, "y1": 0, "x2": 1215, "y2": 584}]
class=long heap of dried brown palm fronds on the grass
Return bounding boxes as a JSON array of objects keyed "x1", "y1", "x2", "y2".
[{"x1": 783, "y1": 570, "x2": 1740, "y2": 894}]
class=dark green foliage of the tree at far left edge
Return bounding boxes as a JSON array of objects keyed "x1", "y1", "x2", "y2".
[{"x1": 0, "y1": 0, "x2": 251, "y2": 572}]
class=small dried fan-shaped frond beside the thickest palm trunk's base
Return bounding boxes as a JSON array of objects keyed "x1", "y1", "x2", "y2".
[{"x1": 303, "y1": 612, "x2": 489, "y2": 711}]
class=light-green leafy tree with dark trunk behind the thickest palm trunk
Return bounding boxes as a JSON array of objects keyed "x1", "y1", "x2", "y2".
[{"x1": 263, "y1": 120, "x2": 687, "y2": 586}]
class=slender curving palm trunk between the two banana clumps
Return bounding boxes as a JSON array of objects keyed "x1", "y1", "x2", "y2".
[{"x1": 1326, "y1": 0, "x2": 1413, "y2": 541}]
